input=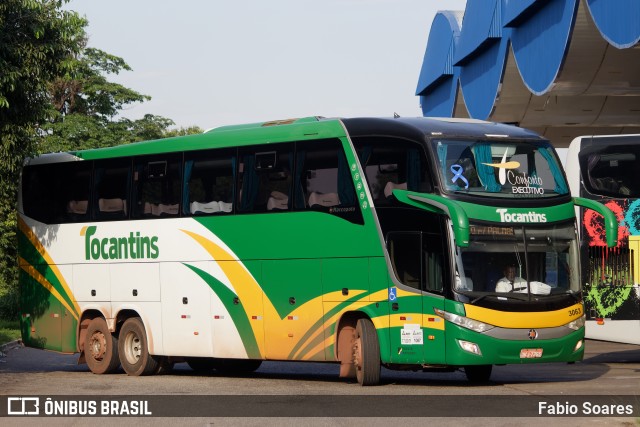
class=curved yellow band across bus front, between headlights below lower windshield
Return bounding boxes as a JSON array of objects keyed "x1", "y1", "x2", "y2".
[{"x1": 464, "y1": 304, "x2": 583, "y2": 328}]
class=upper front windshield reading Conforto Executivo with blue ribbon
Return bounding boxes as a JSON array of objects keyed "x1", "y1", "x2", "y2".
[{"x1": 432, "y1": 139, "x2": 569, "y2": 198}]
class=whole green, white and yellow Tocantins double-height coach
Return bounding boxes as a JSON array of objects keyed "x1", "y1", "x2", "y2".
[{"x1": 18, "y1": 117, "x2": 617, "y2": 385}]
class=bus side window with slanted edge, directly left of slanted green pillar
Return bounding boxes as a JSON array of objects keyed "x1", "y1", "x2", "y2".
[{"x1": 294, "y1": 139, "x2": 362, "y2": 224}]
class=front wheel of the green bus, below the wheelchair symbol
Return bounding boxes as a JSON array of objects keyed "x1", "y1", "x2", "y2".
[{"x1": 353, "y1": 319, "x2": 380, "y2": 386}]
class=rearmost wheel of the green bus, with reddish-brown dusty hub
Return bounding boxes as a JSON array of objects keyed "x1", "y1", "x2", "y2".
[{"x1": 84, "y1": 317, "x2": 120, "y2": 374}]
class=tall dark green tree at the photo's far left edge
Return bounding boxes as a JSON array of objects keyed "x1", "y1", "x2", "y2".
[{"x1": 0, "y1": 0, "x2": 86, "y2": 316}]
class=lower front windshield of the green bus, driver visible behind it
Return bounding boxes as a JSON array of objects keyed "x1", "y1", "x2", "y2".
[{"x1": 455, "y1": 222, "x2": 580, "y2": 300}]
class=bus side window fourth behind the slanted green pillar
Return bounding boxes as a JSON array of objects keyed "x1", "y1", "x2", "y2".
[{"x1": 133, "y1": 155, "x2": 182, "y2": 218}]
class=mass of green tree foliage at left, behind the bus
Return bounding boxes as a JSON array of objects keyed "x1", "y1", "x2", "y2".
[{"x1": 0, "y1": 0, "x2": 202, "y2": 319}]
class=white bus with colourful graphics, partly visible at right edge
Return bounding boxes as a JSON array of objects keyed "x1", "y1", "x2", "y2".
[{"x1": 565, "y1": 135, "x2": 640, "y2": 344}]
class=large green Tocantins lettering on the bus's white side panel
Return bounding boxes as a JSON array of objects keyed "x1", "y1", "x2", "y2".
[{"x1": 80, "y1": 225, "x2": 160, "y2": 261}]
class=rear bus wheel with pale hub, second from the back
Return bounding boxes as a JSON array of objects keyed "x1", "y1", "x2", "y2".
[{"x1": 118, "y1": 317, "x2": 159, "y2": 377}]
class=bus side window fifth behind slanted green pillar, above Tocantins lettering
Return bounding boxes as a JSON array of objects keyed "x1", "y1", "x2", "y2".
[{"x1": 92, "y1": 159, "x2": 131, "y2": 220}]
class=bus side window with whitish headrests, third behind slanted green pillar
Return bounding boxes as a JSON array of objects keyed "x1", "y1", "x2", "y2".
[{"x1": 183, "y1": 150, "x2": 236, "y2": 215}]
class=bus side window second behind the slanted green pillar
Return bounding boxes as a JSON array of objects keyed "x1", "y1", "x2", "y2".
[{"x1": 237, "y1": 144, "x2": 293, "y2": 213}]
